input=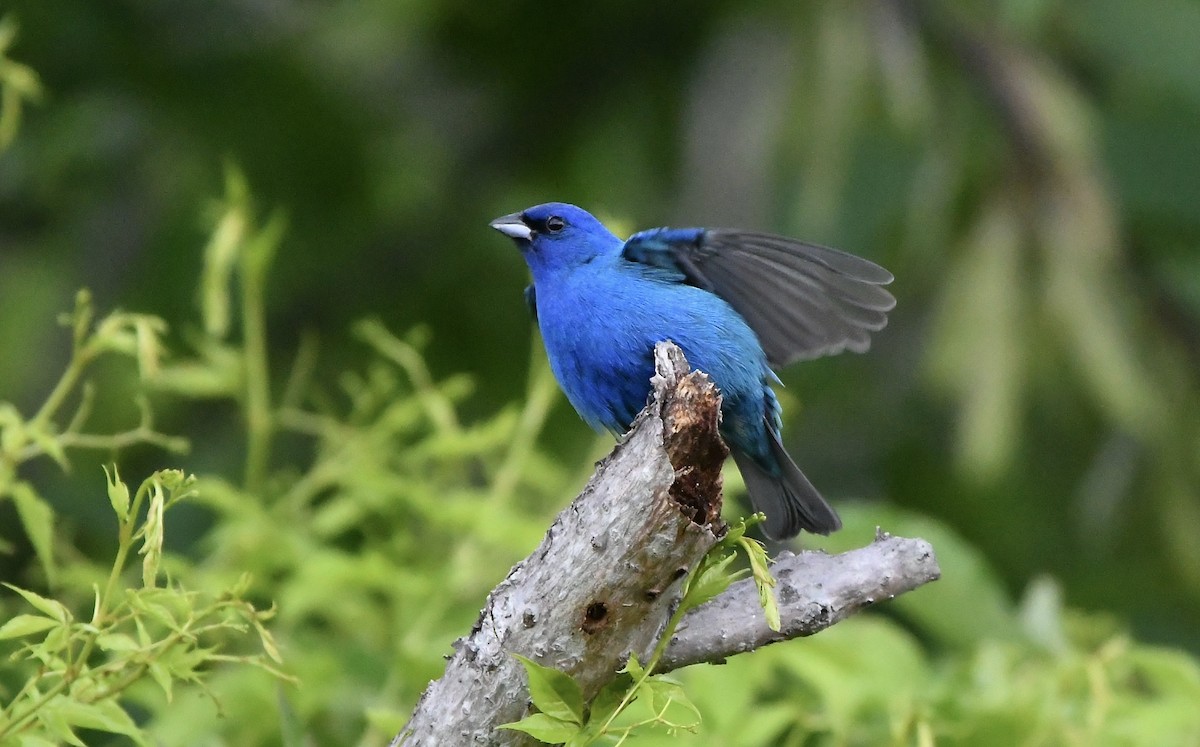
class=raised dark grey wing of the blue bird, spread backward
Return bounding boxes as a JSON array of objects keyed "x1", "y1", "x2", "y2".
[{"x1": 622, "y1": 228, "x2": 895, "y2": 367}]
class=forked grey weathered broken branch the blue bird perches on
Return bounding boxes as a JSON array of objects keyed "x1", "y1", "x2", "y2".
[{"x1": 392, "y1": 343, "x2": 937, "y2": 747}]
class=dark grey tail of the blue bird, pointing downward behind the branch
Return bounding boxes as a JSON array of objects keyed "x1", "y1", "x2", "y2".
[{"x1": 731, "y1": 429, "x2": 841, "y2": 539}]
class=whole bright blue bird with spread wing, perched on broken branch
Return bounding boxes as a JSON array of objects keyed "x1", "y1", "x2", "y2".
[{"x1": 491, "y1": 203, "x2": 895, "y2": 539}]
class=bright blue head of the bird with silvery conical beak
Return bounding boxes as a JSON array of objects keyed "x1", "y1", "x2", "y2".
[{"x1": 491, "y1": 202, "x2": 623, "y2": 281}]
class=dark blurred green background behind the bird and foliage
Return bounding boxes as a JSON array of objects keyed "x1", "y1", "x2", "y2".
[{"x1": 0, "y1": 0, "x2": 1200, "y2": 744}]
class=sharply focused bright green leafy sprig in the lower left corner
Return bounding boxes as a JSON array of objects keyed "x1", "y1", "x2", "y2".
[{"x1": 0, "y1": 467, "x2": 288, "y2": 746}]
